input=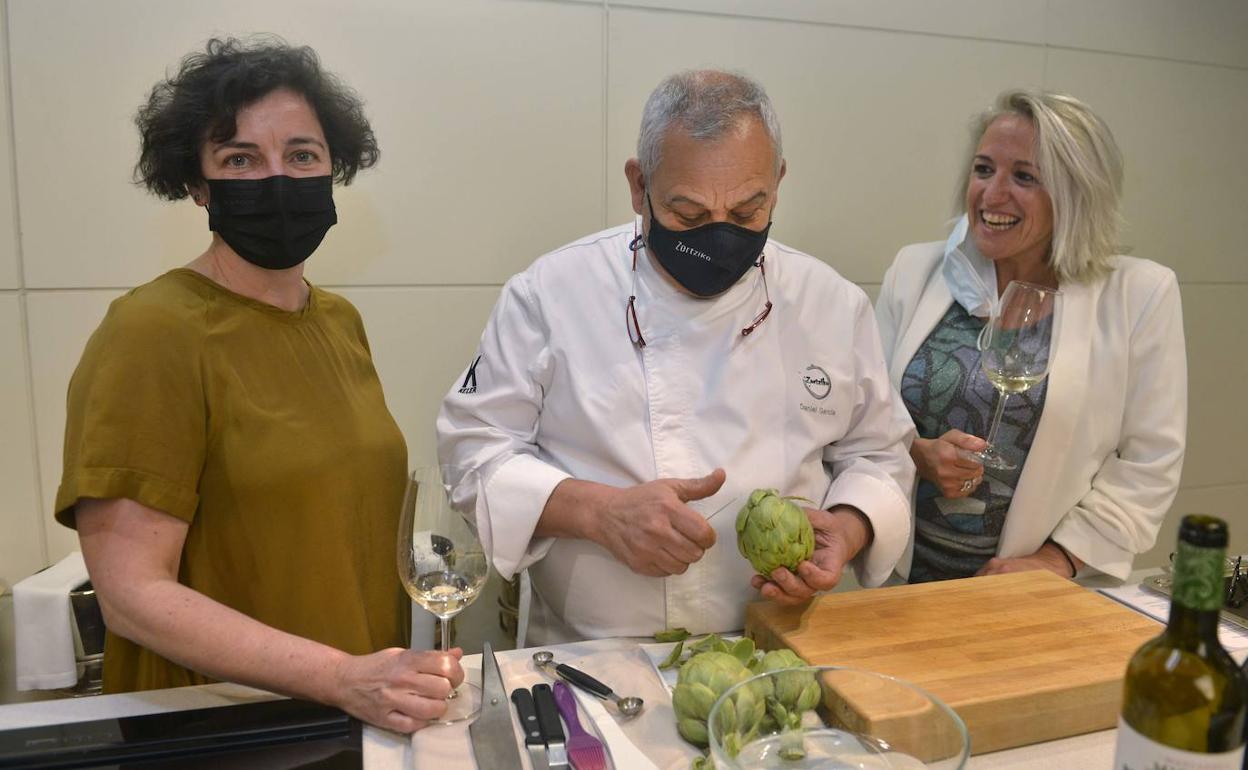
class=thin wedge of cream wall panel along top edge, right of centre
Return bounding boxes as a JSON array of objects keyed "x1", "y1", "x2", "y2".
[{"x1": 608, "y1": 0, "x2": 1045, "y2": 42}]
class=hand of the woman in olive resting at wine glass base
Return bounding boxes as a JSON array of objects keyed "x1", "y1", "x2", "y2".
[{"x1": 327, "y1": 648, "x2": 464, "y2": 733}]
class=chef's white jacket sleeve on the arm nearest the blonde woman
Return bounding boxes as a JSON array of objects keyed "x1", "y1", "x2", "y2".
[{"x1": 824, "y1": 290, "x2": 915, "y2": 587}]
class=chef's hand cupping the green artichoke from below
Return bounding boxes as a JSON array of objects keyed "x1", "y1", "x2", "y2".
[{"x1": 750, "y1": 505, "x2": 872, "y2": 605}]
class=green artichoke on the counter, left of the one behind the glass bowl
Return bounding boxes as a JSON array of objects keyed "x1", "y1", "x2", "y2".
[{"x1": 671, "y1": 651, "x2": 766, "y2": 748}]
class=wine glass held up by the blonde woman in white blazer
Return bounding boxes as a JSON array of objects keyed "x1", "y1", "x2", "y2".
[{"x1": 977, "y1": 281, "x2": 1062, "y2": 470}]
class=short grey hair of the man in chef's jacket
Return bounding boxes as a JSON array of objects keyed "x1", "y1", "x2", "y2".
[{"x1": 636, "y1": 70, "x2": 784, "y2": 178}]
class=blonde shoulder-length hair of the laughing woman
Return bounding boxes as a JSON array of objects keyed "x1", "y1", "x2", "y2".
[{"x1": 958, "y1": 89, "x2": 1122, "y2": 282}]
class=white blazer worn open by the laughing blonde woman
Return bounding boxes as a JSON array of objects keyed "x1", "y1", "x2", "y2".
[{"x1": 876, "y1": 242, "x2": 1187, "y2": 579}]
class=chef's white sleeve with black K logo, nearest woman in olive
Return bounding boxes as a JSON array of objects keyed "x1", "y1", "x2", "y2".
[{"x1": 437, "y1": 273, "x2": 569, "y2": 579}]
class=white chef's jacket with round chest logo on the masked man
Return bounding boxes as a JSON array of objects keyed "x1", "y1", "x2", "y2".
[{"x1": 437, "y1": 222, "x2": 914, "y2": 644}]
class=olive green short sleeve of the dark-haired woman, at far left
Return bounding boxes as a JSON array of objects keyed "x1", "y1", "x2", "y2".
[{"x1": 56, "y1": 290, "x2": 207, "y2": 527}]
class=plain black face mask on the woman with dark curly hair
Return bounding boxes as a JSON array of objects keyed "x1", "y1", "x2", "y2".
[{"x1": 207, "y1": 176, "x2": 338, "y2": 270}]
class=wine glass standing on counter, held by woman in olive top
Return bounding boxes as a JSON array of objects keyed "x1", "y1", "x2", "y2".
[{"x1": 398, "y1": 465, "x2": 489, "y2": 724}]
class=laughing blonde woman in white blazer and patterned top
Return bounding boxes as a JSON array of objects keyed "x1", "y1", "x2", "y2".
[{"x1": 876, "y1": 90, "x2": 1187, "y2": 582}]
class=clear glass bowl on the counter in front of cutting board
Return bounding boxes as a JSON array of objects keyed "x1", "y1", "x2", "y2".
[{"x1": 708, "y1": 666, "x2": 971, "y2": 770}]
